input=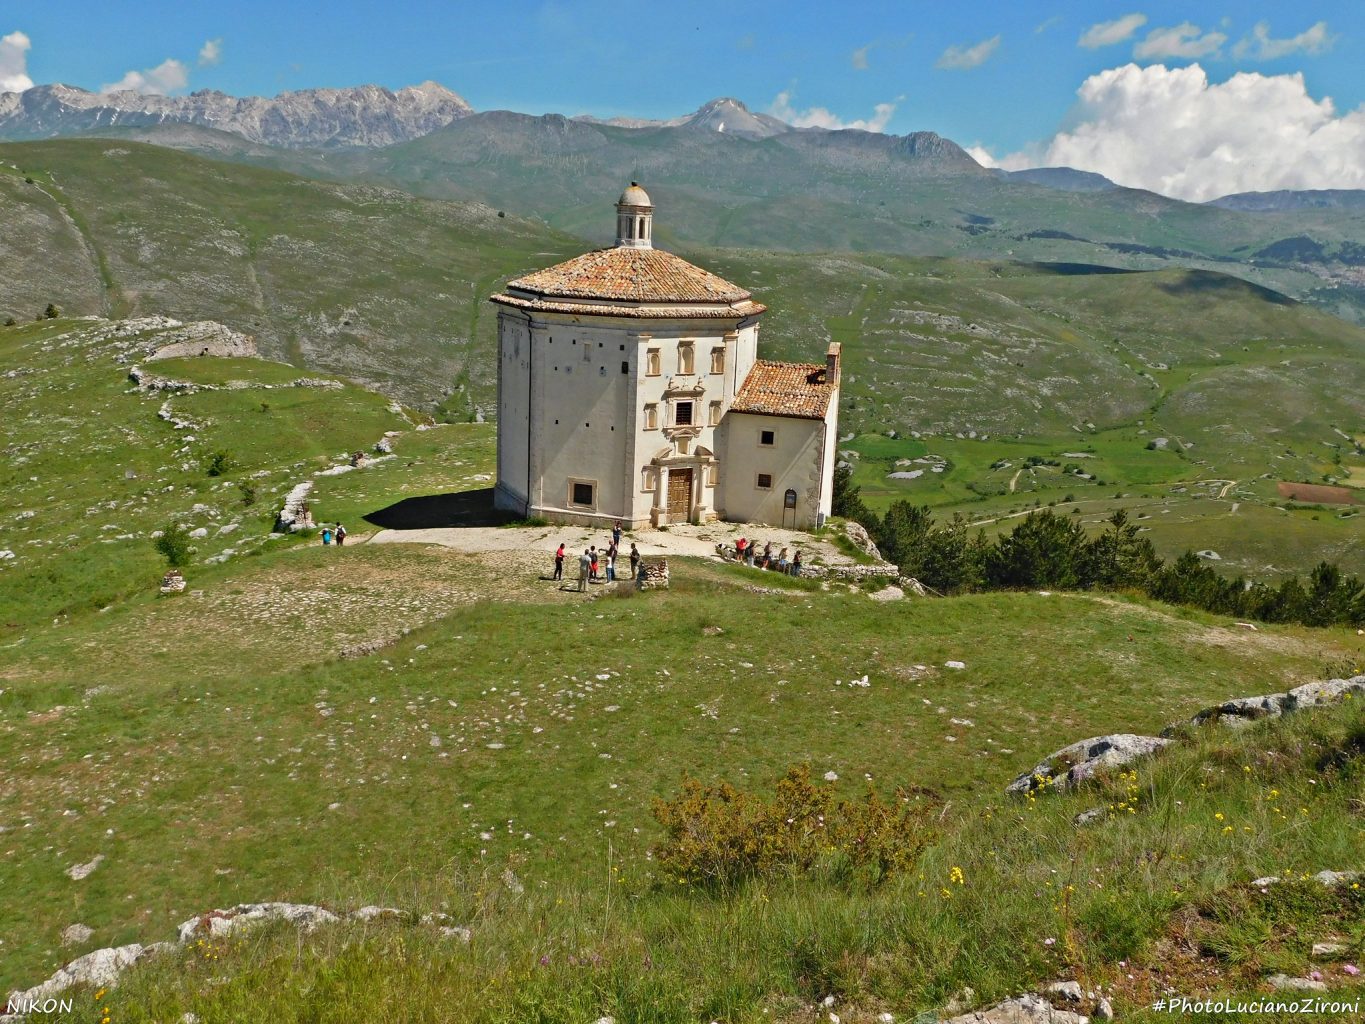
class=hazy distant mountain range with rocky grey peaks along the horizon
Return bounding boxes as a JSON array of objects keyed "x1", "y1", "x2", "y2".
[{"x1": 8, "y1": 82, "x2": 1365, "y2": 329}]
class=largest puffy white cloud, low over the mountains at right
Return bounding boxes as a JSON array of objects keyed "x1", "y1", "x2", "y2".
[{"x1": 973, "y1": 64, "x2": 1365, "y2": 202}]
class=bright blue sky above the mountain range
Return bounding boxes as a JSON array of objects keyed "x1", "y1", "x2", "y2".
[{"x1": 8, "y1": 0, "x2": 1365, "y2": 197}]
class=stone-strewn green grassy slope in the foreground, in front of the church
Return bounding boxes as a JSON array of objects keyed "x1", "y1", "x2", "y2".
[{"x1": 0, "y1": 321, "x2": 1365, "y2": 1021}]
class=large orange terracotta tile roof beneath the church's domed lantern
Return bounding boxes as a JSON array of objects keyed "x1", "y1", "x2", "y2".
[{"x1": 508, "y1": 246, "x2": 749, "y2": 303}]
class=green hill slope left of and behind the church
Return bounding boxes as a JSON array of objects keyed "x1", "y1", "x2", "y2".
[{"x1": 0, "y1": 141, "x2": 571, "y2": 414}]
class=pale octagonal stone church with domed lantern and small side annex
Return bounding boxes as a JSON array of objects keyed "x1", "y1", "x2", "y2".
[{"x1": 491, "y1": 182, "x2": 839, "y2": 528}]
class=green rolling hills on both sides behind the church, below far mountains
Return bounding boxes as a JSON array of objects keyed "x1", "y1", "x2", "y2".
[{"x1": 0, "y1": 139, "x2": 1365, "y2": 575}]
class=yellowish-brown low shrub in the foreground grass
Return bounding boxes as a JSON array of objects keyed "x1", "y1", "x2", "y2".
[{"x1": 654, "y1": 765, "x2": 936, "y2": 886}]
